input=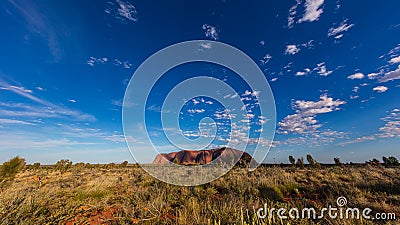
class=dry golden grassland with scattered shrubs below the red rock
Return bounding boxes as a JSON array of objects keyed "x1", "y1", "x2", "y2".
[{"x1": 0, "y1": 155, "x2": 400, "y2": 225}]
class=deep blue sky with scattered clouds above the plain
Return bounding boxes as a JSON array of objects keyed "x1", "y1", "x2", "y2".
[{"x1": 0, "y1": 0, "x2": 400, "y2": 163}]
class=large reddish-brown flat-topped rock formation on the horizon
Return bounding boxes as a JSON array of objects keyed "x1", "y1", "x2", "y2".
[{"x1": 153, "y1": 147, "x2": 252, "y2": 165}]
